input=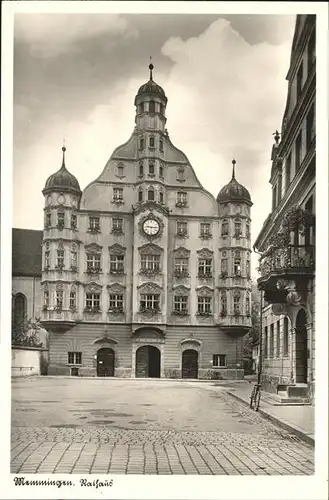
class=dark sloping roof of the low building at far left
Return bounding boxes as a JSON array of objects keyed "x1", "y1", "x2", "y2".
[{"x1": 12, "y1": 228, "x2": 43, "y2": 277}]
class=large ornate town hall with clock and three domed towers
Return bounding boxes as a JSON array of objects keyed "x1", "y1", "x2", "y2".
[{"x1": 42, "y1": 65, "x2": 252, "y2": 378}]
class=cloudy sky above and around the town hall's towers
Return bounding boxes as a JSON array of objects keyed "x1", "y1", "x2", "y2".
[{"x1": 13, "y1": 13, "x2": 295, "y2": 276}]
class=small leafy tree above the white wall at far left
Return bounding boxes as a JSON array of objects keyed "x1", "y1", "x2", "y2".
[{"x1": 11, "y1": 314, "x2": 42, "y2": 347}]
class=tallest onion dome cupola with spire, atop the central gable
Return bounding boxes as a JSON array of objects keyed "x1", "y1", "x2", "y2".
[{"x1": 135, "y1": 63, "x2": 168, "y2": 130}]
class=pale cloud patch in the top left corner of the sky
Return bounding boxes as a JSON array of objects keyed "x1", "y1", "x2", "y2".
[{"x1": 15, "y1": 14, "x2": 138, "y2": 58}]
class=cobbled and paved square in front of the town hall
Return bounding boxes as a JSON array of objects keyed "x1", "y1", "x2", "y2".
[{"x1": 11, "y1": 377, "x2": 314, "y2": 475}]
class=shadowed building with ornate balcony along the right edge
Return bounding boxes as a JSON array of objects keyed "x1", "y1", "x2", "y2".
[{"x1": 254, "y1": 15, "x2": 316, "y2": 396}]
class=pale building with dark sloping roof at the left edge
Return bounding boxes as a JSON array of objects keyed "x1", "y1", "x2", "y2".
[{"x1": 12, "y1": 229, "x2": 47, "y2": 347}]
